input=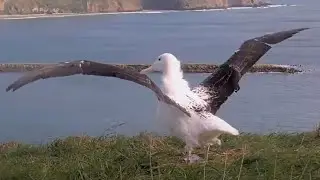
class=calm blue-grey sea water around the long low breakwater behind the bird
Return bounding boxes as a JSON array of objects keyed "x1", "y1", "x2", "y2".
[{"x1": 0, "y1": 0, "x2": 320, "y2": 143}]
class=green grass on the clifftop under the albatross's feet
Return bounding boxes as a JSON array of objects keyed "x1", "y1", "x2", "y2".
[{"x1": 0, "y1": 132, "x2": 320, "y2": 180}]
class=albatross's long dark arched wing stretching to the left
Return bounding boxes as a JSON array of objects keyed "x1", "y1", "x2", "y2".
[{"x1": 6, "y1": 61, "x2": 191, "y2": 117}]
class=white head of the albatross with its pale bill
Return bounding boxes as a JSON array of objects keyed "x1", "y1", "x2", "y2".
[{"x1": 140, "y1": 53, "x2": 180, "y2": 74}]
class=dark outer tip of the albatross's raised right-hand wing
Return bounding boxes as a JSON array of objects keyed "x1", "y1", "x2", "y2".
[{"x1": 255, "y1": 28, "x2": 310, "y2": 44}]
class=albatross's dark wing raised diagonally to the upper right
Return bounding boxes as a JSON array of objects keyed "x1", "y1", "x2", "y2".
[{"x1": 193, "y1": 28, "x2": 309, "y2": 114}]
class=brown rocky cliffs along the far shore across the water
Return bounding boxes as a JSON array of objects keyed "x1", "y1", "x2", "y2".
[{"x1": 0, "y1": 0, "x2": 271, "y2": 15}]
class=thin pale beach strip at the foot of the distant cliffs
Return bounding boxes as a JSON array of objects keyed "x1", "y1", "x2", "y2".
[{"x1": 0, "y1": 4, "x2": 296, "y2": 20}]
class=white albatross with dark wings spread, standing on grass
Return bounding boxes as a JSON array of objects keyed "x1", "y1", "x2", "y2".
[{"x1": 6, "y1": 28, "x2": 309, "y2": 162}]
